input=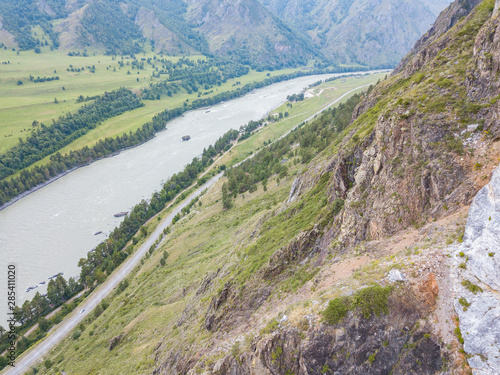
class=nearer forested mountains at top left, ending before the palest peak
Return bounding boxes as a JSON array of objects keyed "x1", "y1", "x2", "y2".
[{"x1": 0, "y1": 0, "x2": 321, "y2": 69}]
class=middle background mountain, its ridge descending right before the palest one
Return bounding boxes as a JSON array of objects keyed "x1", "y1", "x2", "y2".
[{"x1": 187, "y1": 0, "x2": 320, "y2": 67}]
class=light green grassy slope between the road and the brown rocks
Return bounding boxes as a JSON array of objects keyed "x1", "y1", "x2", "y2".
[{"x1": 38, "y1": 169, "x2": 296, "y2": 374}]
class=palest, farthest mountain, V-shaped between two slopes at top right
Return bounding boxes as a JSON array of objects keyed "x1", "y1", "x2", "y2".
[{"x1": 260, "y1": 0, "x2": 451, "y2": 66}]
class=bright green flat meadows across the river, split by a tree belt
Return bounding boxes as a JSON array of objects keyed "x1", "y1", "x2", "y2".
[{"x1": 0, "y1": 47, "x2": 300, "y2": 153}]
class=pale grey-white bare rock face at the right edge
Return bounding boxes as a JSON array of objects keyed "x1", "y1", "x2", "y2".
[{"x1": 455, "y1": 168, "x2": 500, "y2": 375}]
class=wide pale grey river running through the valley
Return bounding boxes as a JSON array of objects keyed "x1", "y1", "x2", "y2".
[{"x1": 0, "y1": 74, "x2": 364, "y2": 327}]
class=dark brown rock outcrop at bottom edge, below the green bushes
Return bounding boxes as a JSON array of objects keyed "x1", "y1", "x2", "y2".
[{"x1": 208, "y1": 290, "x2": 443, "y2": 375}]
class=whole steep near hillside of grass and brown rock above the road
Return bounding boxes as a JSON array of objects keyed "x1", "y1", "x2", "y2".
[{"x1": 28, "y1": 0, "x2": 500, "y2": 374}]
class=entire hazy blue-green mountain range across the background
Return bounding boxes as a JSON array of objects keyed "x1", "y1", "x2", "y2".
[{"x1": 0, "y1": 0, "x2": 449, "y2": 69}]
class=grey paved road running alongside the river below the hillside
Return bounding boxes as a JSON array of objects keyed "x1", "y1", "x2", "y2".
[{"x1": 1, "y1": 78, "x2": 378, "y2": 375}]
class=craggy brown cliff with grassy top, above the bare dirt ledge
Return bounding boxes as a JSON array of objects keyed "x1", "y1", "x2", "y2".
[{"x1": 306, "y1": 1, "x2": 500, "y2": 250}]
